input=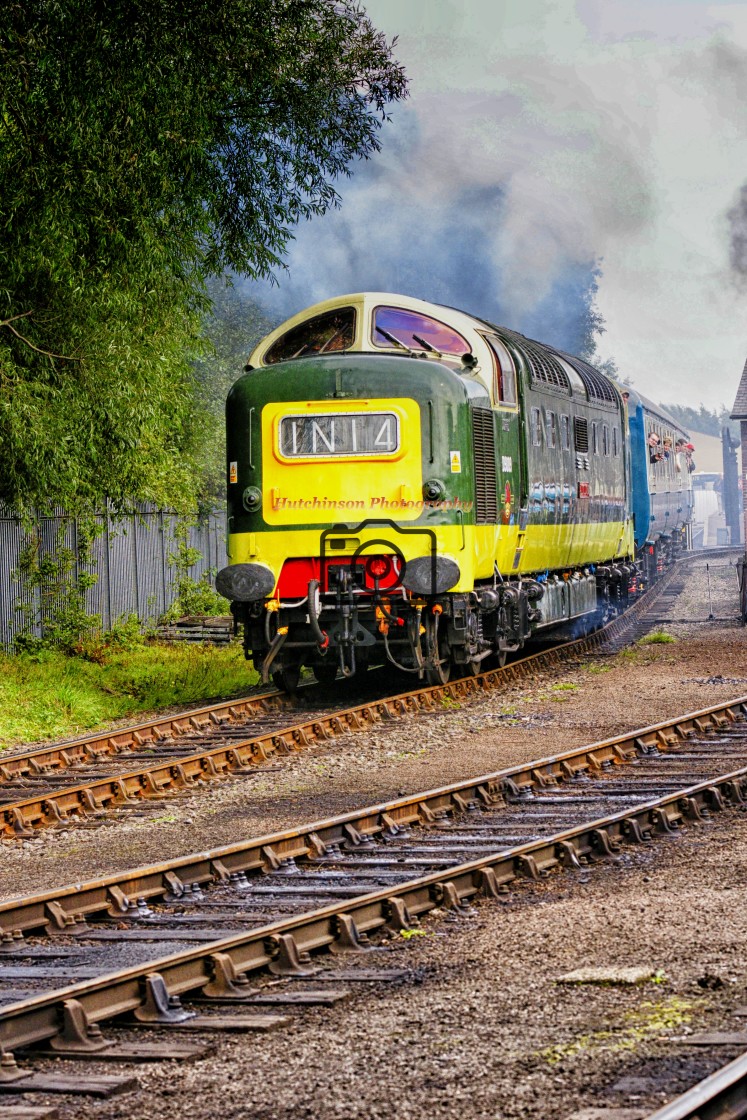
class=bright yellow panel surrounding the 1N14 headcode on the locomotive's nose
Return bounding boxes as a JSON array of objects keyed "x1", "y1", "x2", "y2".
[{"x1": 262, "y1": 396, "x2": 422, "y2": 526}]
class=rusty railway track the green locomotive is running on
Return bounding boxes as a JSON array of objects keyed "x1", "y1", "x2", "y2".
[{"x1": 0, "y1": 550, "x2": 723, "y2": 839}]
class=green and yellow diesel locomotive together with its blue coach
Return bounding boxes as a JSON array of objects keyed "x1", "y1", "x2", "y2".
[{"x1": 216, "y1": 292, "x2": 692, "y2": 690}]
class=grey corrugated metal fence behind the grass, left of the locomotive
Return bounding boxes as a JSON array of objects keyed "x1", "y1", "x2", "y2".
[{"x1": 0, "y1": 506, "x2": 226, "y2": 648}]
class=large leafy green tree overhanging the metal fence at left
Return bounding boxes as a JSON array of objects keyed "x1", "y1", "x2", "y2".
[{"x1": 0, "y1": 0, "x2": 405, "y2": 507}]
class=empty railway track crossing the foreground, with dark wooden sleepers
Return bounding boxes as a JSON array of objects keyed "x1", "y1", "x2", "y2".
[{"x1": 0, "y1": 697, "x2": 747, "y2": 1093}]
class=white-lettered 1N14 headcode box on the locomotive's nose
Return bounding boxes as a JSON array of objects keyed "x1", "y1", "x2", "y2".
[{"x1": 280, "y1": 412, "x2": 400, "y2": 459}]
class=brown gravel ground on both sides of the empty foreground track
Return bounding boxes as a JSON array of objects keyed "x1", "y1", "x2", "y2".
[{"x1": 0, "y1": 561, "x2": 747, "y2": 1120}]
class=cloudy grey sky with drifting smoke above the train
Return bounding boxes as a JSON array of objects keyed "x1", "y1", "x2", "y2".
[{"x1": 244, "y1": 0, "x2": 747, "y2": 408}]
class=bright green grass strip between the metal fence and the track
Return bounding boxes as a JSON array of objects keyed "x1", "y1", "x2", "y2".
[{"x1": 0, "y1": 642, "x2": 258, "y2": 750}]
